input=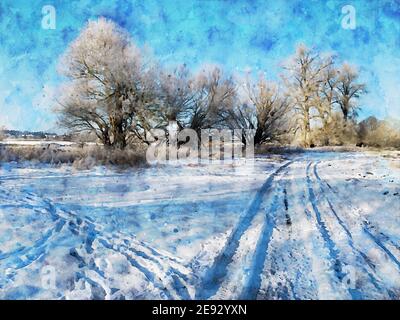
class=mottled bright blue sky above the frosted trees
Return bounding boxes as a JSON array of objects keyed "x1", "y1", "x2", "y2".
[{"x1": 0, "y1": 0, "x2": 400, "y2": 131}]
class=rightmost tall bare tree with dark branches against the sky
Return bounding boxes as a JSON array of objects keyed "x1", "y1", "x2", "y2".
[{"x1": 336, "y1": 63, "x2": 366, "y2": 122}]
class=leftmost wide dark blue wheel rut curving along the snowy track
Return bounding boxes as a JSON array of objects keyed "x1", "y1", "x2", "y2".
[{"x1": 196, "y1": 161, "x2": 293, "y2": 299}]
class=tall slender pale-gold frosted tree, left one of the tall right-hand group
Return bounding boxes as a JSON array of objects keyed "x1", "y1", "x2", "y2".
[{"x1": 284, "y1": 45, "x2": 332, "y2": 146}]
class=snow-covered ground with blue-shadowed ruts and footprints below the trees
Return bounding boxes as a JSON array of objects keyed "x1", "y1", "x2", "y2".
[{"x1": 0, "y1": 152, "x2": 400, "y2": 299}]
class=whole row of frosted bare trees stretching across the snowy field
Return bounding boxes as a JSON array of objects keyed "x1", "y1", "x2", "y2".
[{"x1": 57, "y1": 18, "x2": 366, "y2": 149}]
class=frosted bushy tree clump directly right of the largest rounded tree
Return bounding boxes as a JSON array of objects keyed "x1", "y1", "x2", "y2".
[{"x1": 154, "y1": 65, "x2": 236, "y2": 146}]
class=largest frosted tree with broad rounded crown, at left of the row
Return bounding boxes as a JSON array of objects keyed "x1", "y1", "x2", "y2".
[{"x1": 58, "y1": 18, "x2": 155, "y2": 149}]
